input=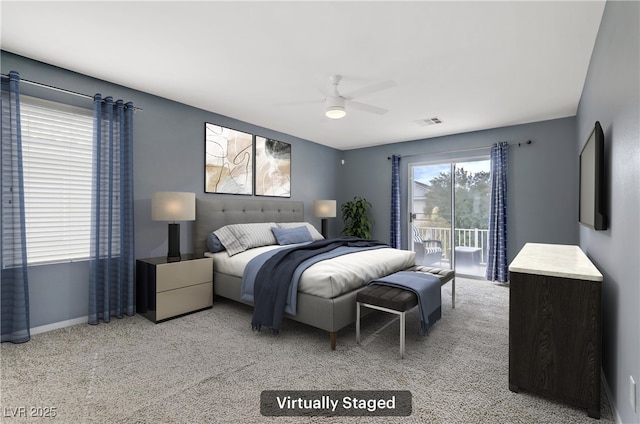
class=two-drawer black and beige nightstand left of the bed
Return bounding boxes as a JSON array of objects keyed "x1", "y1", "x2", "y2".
[{"x1": 136, "y1": 255, "x2": 213, "y2": 323}]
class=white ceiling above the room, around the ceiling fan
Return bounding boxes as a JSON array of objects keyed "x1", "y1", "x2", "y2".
[{"x1": 0, "y1": 0, "x2": 605, "y2": 150}]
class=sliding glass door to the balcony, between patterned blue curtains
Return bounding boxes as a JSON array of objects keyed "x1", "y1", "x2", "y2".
[{"x1": 409, "y1": 157, "x2": 490, "y2": 277}]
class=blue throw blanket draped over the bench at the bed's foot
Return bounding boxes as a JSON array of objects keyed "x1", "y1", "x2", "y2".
[{"x1": 368, "y1": 271, "x2": 442, "y2": 336}]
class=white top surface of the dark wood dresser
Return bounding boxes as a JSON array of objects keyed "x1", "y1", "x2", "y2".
[{"x1": 509, "y1": 243, "x2": 602, "y2": 281}]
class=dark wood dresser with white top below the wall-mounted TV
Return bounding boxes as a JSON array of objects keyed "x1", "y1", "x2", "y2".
[{"x1": 509, "y1": 243, "x2": 602, "y2": 418}]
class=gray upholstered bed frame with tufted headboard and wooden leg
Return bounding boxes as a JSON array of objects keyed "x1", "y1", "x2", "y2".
[{"x1": 193, "y1": 198, "x2": 415, "y2": 350}]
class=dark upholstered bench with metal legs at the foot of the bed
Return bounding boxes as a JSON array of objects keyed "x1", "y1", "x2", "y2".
[{"x1": 356, "y1": 265, "x2": 455, "y2": 358}]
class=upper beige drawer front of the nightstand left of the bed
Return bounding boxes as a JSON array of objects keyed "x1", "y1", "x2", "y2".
[{"x1": 156, "y1": 258, "x2": 213, "y2": 293}]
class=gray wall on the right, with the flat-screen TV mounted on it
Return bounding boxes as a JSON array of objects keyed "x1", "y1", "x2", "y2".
[{"x1": 575, "y1": 1, "x2": 640, "y2": 423}]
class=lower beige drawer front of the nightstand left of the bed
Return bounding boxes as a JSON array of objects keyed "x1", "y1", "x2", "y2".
[{"x1": 156, "y1": 282, "x2": 213, "y2": 321}]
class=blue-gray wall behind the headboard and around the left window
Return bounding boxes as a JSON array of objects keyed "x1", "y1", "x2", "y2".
[{"x1": 0, "y1": 51, "x2": 340, "y2": 327}]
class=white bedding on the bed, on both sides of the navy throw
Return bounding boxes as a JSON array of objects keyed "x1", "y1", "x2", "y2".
[{"x1": 205, "y1": 245, "x2": 415, "y2": 299}]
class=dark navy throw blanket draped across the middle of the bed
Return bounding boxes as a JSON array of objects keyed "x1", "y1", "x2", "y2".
[{"x1": 251, "y1": 237, "x2": 387, "y2": 334}]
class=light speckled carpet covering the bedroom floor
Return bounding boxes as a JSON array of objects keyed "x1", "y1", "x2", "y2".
[{"x1": 0, "y1": 278, "x2": 614, "y2": 424}]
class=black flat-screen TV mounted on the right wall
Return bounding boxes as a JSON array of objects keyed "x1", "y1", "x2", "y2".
[{"x1": 579, "y1": 122, "x2": 607, "y2": 230}]
